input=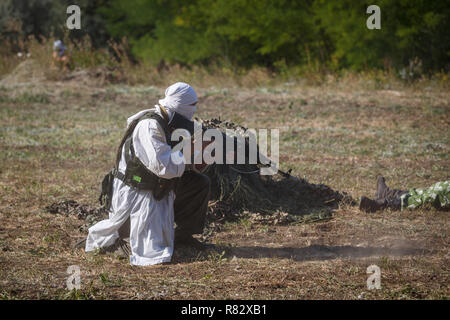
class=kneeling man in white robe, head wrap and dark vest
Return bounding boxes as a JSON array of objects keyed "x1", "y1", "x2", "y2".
[{"x1": 85, "y1": 82, "x2": 210, "y2": 266}]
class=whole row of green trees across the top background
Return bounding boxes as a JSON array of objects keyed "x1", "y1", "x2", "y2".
[{"x1": 0, "y1": 0, "x2": 450, "y2": 72}]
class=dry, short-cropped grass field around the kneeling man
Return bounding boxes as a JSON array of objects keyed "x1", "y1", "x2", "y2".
[{"x1": 0, "y1": 64, "x2": 450, "y2": 299}]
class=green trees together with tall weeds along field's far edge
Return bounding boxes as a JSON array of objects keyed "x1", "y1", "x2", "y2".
[{"x1": 0, "y1": 0, "x2": 450, "y2": 84}]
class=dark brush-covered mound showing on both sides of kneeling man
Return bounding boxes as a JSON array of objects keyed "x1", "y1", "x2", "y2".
[{"x1": 46, "y1": 119, "x2": 354, "y2": 230}]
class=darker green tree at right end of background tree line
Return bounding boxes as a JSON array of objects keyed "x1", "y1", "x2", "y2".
[{"x1": 314, "y1": 0, "x2": 450, "y2": 70}]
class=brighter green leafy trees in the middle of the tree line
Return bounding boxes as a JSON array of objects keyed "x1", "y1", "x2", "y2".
[{"x1": 102, "y1": 0, "x2": 320, "y2": 66}]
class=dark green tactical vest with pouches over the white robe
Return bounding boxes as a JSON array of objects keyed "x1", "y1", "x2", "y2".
[{"x1": 99, "y1": 108, "x2": 178, "y2": 210}]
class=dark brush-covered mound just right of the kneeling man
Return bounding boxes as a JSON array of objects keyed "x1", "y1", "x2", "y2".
[{"x1": 196, "y1": 119, "x2": 353, "y2": 225}]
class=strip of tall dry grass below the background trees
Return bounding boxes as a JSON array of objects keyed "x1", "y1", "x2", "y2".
[{"x1": 0, "y1": 34, "x2": 450, "y2": 90}]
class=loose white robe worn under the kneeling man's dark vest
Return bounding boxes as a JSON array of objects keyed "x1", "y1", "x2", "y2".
[{"x1": 85, "y1": 106, "x2": 185, "y2": 266}]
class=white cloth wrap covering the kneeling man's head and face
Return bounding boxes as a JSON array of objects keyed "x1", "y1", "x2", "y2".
[{"x1": 159, "y1": 82, "x2": 198, "y2": 119}]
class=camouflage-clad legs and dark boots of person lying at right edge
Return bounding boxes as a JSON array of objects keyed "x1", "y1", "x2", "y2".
[{"x1": 359, "y1": 177, "x2": 450, "y2": 212}]
